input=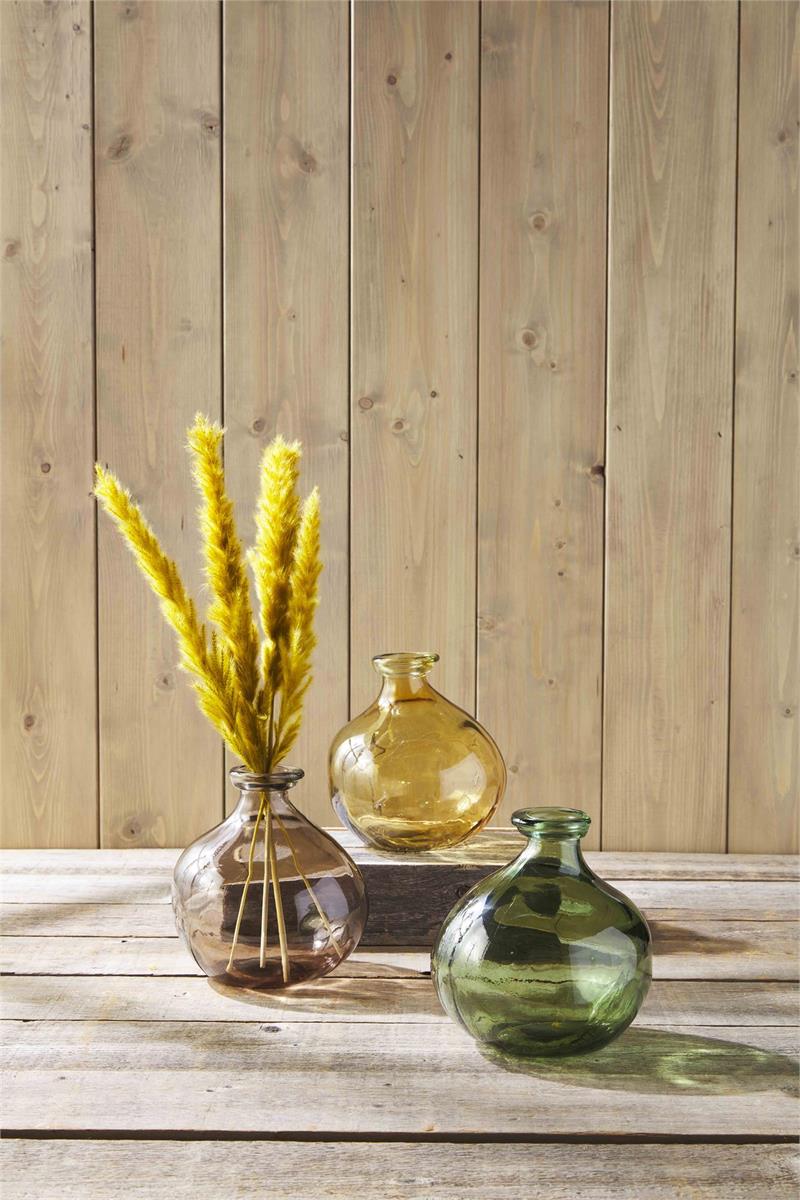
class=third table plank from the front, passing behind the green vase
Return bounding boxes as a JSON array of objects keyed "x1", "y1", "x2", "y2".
[{"x1": 4, "y1": 974, "x2": 800, "y2": 1027}]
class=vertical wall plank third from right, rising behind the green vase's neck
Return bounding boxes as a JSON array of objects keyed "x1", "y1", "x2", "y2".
[{"x1": 479, "y1": 2, "x2": 608, "y2": 845}]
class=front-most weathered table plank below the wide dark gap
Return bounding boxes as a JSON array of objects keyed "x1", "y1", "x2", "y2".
[{"x1": 0, "y1": 1138, "x2": 800, "y2": 1200}]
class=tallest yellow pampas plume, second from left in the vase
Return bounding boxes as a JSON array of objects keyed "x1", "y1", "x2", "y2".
[{"x1": 188, "y1": 413, "x2": 266, "y2": 769}]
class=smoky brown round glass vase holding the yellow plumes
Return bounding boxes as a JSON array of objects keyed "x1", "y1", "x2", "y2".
[{"x1": 173, "y1": 767, "x2": 367, "y2": 988}]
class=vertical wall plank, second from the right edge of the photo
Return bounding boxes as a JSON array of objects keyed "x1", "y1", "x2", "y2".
[{"x1": 603, "y1": 2, "x2": 738, "y2": 851}]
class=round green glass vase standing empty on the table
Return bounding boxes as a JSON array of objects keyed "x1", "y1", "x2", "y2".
[{"x1": 433, "y1": 809, "x2": 651, "y2": 1058}]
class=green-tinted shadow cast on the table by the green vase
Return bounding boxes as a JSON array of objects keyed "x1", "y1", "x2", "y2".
[{"x1": 481, "y1": 1028, "x2": 800, "y2": 1096}]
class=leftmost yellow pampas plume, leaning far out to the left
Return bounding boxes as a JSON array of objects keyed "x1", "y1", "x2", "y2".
[{"x1": 95, "y1": 464, "x2": 259, "y2": 770}]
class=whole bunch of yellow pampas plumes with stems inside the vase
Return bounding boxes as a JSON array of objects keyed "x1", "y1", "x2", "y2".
[{"x1": 95, "y1": 413, "x2": 326, "y2": 982}]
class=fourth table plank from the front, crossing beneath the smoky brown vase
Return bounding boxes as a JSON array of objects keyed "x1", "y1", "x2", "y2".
[{"x1": 0, "y1": 905, "x2": 800, "y2": 980}]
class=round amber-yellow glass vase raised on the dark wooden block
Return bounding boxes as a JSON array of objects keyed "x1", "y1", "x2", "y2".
[{"x1": 330, "y1": 653, "x2": 506, "y2": 852}]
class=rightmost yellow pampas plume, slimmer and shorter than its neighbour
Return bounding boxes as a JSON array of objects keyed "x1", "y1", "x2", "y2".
[{"x1": 275, "y1": 488, "x2": 323, "y2": 761}]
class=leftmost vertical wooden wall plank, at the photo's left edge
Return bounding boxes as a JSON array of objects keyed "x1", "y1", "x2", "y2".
[{"x1": 0, "y1": 2, "x2": 97, "y2": 847}]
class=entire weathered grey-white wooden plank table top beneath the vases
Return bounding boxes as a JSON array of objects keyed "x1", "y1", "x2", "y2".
[{"x1": 2, "y1": 839, "x2": 799, "y2": 1200}]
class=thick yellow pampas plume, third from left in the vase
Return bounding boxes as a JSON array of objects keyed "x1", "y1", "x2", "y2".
[{"x1": 248, "y1": 437, "x2": 300, "y2": 710}]
